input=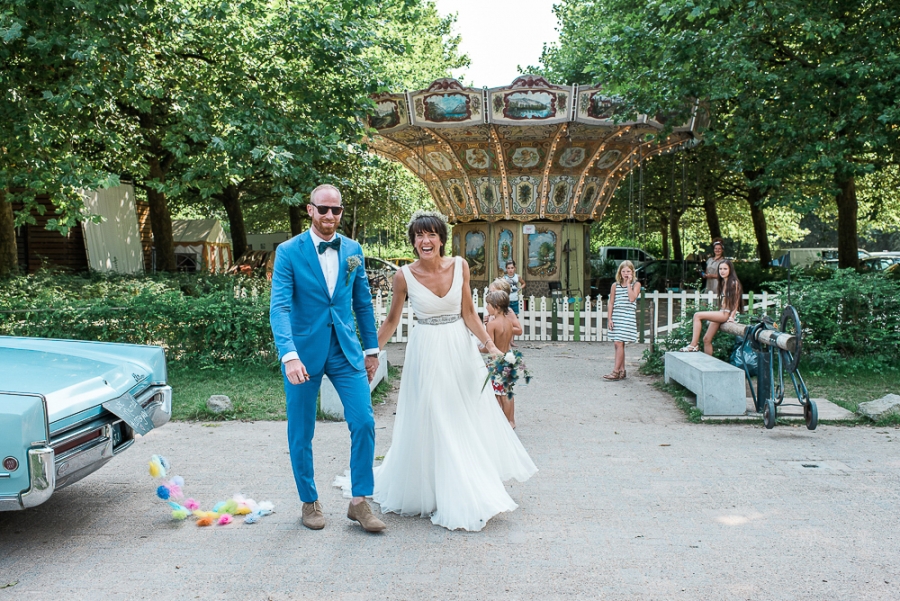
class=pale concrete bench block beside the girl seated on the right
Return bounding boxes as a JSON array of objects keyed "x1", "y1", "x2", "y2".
[{"x1": 665, "y1": 352, "x2": 747, "y2": 415}]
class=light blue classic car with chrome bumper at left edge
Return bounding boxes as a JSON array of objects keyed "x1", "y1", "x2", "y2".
[{"x1": 0, "y1": 336, "x2": 172, "y2": 511}]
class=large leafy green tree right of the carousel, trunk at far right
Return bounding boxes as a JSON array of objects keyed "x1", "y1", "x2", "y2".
[{"x1": 543, "y1": 0, "x2": 900, "y2": 267}]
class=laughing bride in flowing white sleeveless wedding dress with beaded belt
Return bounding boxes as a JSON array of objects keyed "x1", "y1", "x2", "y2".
[{"x1": 372, "y1": 213, "x2": 537, "y2": 530}]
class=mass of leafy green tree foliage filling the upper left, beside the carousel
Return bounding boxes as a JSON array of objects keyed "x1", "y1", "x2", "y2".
[{"x1": 0, "y1": 0, "x2": 465, "y2": 273}]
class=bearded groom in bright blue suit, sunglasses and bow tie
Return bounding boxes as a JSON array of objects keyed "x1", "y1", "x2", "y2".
[{"x1": 269, "y1": 184, "x2": 385, "y2": 532}]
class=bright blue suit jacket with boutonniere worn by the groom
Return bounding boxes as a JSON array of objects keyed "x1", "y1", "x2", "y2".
[{"x1": 269, "y1": 231, "x2": 378, "y2": 375}]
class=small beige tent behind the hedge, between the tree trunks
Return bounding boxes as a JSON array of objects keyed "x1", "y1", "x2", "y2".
[{"x1": 172, "y1": 219, "x2": 232, "y2": 272}]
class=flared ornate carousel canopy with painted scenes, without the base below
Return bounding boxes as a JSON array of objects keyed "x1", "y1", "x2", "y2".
[{"x1": 369, "y1": 75, "x2": 697, "y2": 222}]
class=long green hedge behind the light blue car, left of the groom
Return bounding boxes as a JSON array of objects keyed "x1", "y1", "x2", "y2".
[{"x1": 0, "y1": 273, "x2": 277, "y2": 366}]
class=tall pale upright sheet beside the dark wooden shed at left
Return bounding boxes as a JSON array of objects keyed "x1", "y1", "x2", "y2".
[{"x1": 82, "y1": 184, "x2": 144, "y2": 273}]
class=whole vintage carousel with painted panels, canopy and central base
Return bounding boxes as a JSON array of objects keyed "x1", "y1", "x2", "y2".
[{"x1": 369, "y1": 75, "x2": 697, "y2": 296}]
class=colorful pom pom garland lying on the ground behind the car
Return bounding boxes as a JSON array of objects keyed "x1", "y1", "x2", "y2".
[{"x1": 149, "y1": 455, "x2": 275, "y2": 527}]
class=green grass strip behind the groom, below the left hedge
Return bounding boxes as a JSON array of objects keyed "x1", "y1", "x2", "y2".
[{"x1": 169, "y1": 365, "x2": 400, "y2": 421}]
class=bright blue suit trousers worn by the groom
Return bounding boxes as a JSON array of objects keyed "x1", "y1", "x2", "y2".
[{"x1": 281, "y1": 330, "x2": 375, "y2": 503}]
